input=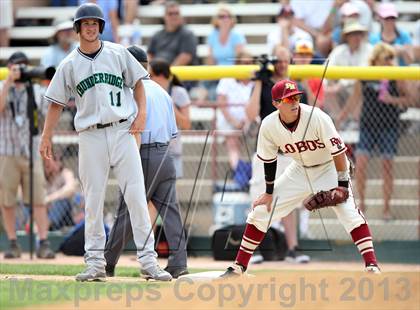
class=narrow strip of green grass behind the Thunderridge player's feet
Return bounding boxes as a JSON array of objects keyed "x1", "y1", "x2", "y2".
[{"x1": 0, "y1": 264, "x2": 211, "y2": 277}]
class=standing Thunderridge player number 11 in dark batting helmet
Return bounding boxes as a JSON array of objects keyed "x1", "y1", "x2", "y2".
[{"x1": 40, "y1": 3, "x2": 171, "y2": 281}]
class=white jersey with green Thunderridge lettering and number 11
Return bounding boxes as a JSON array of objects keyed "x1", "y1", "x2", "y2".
[{"x1": 45, "y1": 41, "x2": 147, "y2": 132}]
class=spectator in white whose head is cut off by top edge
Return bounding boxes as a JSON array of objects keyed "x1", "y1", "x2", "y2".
[{"x1": 290, "y1": 0, "x2": 336, "y2": 57}]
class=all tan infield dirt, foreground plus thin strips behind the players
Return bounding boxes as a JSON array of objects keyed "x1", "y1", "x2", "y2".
[{"x1": 0, "y1": 255, "x2": 420, "y2": 310}]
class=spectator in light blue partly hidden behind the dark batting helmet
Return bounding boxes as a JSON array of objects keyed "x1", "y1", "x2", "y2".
[{"x1": 79, "y1": 0, "x2": 120, "y2": 43}]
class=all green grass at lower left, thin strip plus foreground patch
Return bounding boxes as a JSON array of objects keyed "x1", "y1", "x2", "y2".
[{"x1": 0, "y1": 264, "x2": 217, "y2": 310}]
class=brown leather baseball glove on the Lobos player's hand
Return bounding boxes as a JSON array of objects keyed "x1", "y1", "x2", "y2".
[{"x1": 303, "y1": 186, "x2": 349, "y2": 211}]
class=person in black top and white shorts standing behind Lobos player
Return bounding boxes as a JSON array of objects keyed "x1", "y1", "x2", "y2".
[{"x1": 245, "y1": 45, "x2": 310, "y2": 263}]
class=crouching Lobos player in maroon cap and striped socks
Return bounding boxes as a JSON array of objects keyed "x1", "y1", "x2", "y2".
[{"x1": 222, "y1": 80, "x2": 380, "y2": 277}]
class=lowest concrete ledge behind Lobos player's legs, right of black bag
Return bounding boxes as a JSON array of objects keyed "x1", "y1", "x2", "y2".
[{"x1": 308, "y1": 219, "x2": 420, "y2": 241}]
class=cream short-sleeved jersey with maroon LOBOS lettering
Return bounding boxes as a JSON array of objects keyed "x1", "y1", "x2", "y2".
[{"x1": 257, "y1": 104, "x2": 346, "y2": 167}]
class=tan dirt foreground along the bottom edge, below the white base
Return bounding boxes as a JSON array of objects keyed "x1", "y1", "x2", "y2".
[{"x1": 22, "y1": 270, "x2": 420, "y2": 310}]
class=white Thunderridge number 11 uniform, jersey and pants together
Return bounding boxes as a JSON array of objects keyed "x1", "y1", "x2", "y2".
[{"x1": 45, "y1": 42, "x2": 157, "y2": 270}]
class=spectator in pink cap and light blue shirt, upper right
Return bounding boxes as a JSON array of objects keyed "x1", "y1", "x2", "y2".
[{"x1": 369, "y1": 2, "x2": 414, "y2": 66}]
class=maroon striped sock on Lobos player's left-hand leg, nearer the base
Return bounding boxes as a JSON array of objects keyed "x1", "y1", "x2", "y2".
[{"x1": 236, "y1": 224, "x2": 265, "y2": 270}]
